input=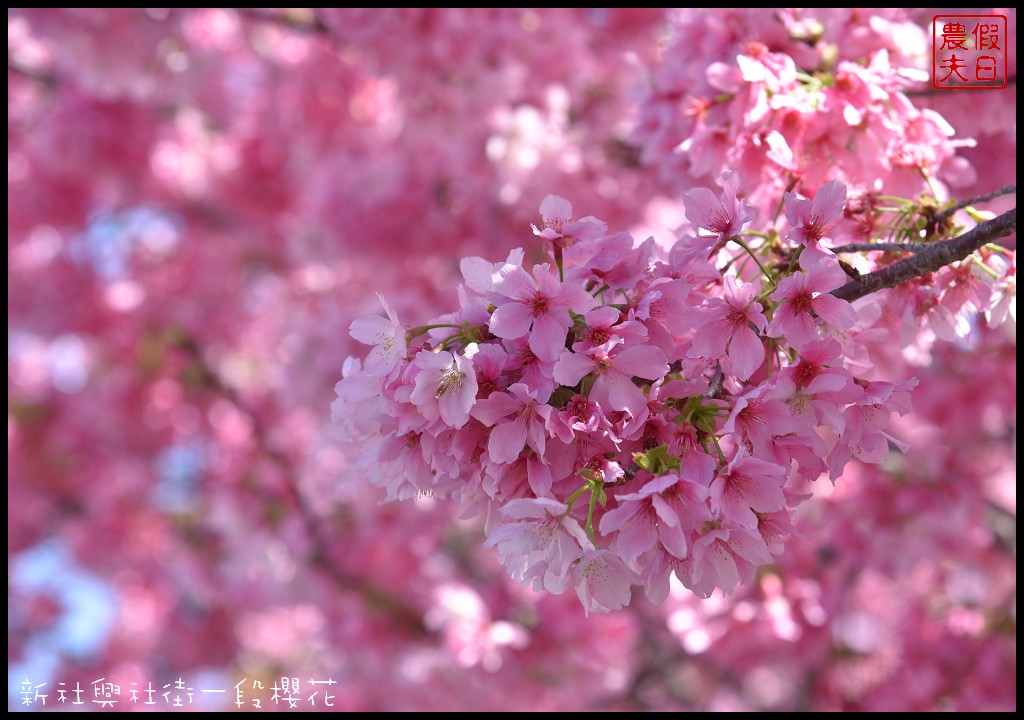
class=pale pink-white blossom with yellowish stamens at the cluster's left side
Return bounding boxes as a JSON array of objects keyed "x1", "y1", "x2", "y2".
[{"x1": 410, "y1": 344, "x2": 477, "y2": 428}]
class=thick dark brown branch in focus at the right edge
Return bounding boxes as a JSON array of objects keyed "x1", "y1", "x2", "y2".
[{"x1": 831, "y1": 208, "x2": 1017, "y2": 301}]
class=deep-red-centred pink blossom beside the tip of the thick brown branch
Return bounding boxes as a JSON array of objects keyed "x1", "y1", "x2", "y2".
[{"x1": 766, "y1": 262, "x2": 857, "y2": 350}]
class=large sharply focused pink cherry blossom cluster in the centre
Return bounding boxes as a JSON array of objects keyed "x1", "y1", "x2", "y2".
[{"x1": 333, "y1": 177, "x2": 942, "y2": 611}]
